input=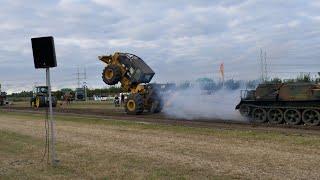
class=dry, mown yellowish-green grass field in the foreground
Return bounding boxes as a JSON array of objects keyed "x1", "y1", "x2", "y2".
[{"x1": 0, "y1": 112, "x2": 320, "y2": 179}]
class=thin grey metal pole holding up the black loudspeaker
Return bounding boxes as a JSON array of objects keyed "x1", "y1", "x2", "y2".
[{"x1": 46, "y1": 68, "x2": 59, "y2": 166}]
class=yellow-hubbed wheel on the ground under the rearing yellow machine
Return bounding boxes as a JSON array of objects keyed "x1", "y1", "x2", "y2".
[{"x1": 126, "y1": 94, "x2": 144, "y2": 114}]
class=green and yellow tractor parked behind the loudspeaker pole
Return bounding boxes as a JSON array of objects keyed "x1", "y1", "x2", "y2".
[{"x1": 30, "y1": 86, "x2": 57, "y2": 108}]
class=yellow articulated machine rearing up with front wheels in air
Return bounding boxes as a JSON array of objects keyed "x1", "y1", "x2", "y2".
[{"x1": 98, "y1": 52, "x2": 163, "y2": 114}]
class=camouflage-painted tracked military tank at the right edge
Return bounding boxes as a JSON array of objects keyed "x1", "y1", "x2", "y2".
[{"x1": 236, "y1": 82, "x2": 320, "y2": 126}]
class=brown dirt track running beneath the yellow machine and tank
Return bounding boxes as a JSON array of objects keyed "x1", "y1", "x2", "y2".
[{"x1": 1, "y1": 107, "x2": 320, "y2": 135}]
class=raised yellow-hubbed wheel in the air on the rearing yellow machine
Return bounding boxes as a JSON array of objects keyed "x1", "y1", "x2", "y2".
[{"x1": 102, "y1": 64, "x2": 121, "y2": 85}]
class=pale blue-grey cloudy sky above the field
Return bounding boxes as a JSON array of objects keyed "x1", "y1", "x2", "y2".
[{"x1": 0, "y1": 0, "x2": 320, "y2": 92}]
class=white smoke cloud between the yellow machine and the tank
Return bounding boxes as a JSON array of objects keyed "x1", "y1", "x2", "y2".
[{"x1": 163, "y1": 86, "x2": 245, "y2": 121}]
